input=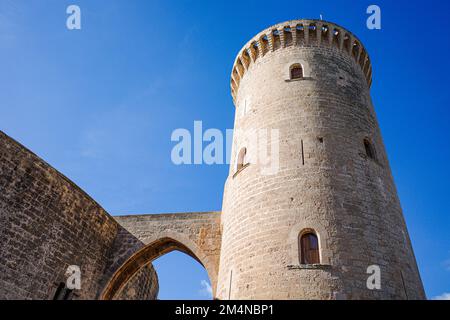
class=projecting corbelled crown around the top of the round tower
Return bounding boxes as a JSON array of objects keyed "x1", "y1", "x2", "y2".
[{"x1": 231, "y1": 19, "x2": 372, "y2": 101}]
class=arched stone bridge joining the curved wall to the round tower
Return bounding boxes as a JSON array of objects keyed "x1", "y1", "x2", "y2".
[{"x1": 98, "y1": 212, "x2": 221, "y2": 300}]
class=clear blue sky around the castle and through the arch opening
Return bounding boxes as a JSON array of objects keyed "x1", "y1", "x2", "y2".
[{"x1": 0, "y1": 0, "x2": 450, "y2": 299}]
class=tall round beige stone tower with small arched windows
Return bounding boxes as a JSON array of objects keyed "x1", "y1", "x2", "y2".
[{"x1": 216, "y1": 20, "x2": 425, "y2": 299}]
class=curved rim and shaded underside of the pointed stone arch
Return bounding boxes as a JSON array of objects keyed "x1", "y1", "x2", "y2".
[{"x1": 101, "y1": 235, "x2": 216, "y2": 300}]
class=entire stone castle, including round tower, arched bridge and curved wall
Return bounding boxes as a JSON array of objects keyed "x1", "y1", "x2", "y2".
[{"x1": 0, "y1": 20, "x2": 425, "y2": 299}]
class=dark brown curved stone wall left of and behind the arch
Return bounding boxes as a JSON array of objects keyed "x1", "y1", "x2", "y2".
[{"x1": 0, "y1": 132, "x2": 158, "y2": 299}]
